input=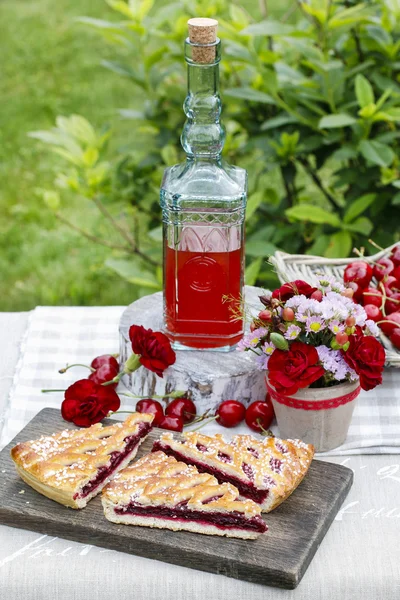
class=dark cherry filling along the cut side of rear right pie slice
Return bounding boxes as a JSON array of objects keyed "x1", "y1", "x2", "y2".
[{"x1": 152, "y1": 440, "x2": 269, "y2": 504}]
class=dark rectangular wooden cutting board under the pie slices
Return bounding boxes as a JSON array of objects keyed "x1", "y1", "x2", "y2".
[{"x1": 0, "y1": 408, "x2": 353, "y2": 589}]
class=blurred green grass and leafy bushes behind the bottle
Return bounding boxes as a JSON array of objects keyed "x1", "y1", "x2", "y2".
[{"x1": 0, "y1": 0, "x2": 400, "y2": 310}]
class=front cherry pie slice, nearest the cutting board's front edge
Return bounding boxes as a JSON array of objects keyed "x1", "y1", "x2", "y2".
[{"x1": 101, "y1": 452, "x2": 267, "y2": 539}]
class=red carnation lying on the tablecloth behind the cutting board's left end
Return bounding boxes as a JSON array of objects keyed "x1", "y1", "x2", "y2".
[{"x1": 61, "y1": 379, "x2": 121, "y2": 427}]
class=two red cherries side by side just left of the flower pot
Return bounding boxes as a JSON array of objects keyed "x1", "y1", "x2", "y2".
[{"x1": 216, "y1": 394, "x2": 274, "y2": 433}]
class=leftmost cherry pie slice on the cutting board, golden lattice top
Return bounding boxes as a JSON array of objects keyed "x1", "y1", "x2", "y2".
[{"x1": 11, "y1": 413, "x2": 154, "y2": 508}]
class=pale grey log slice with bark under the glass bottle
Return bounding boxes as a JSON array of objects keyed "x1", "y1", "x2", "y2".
[{"x1": 119, "y1": 286, "x2": 266, "y2": 414}]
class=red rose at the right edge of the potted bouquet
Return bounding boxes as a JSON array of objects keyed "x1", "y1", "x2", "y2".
[{"x1": 342, "y1": 327, "x2": 386, "y2": 391}]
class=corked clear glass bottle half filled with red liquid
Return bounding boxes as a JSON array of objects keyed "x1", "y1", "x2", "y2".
[{"x1": 160, "y1": 19, "x2": 247, "y2": 351}]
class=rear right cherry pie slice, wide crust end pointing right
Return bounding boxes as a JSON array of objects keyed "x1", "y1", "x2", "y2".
[{"x1": 153, "y1": 432, "x2": 314, "y2": 512}]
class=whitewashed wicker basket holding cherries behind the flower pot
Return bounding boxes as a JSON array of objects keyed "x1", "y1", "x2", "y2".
[{"x1": 270, "y1": 243, "x2": 400, "y2": 367}]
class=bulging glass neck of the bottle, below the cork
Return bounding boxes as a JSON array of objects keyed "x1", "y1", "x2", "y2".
[{"x1": 181, "y1": 40, "x2": 225, "y2": 160}]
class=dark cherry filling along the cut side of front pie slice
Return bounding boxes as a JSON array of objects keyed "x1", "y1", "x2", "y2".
[{"x1": 114, "y1": 499, "x2": 268, "y2": 533}]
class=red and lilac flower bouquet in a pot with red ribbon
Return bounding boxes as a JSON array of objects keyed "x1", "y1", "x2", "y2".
[{"x1": 238, "y1": 278, "x2": 385, "y2": 451}]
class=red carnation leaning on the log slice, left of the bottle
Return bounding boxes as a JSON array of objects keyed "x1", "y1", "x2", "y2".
[{"x1": 129, "y1": 325, "x2": 176, "y2": 377}]
